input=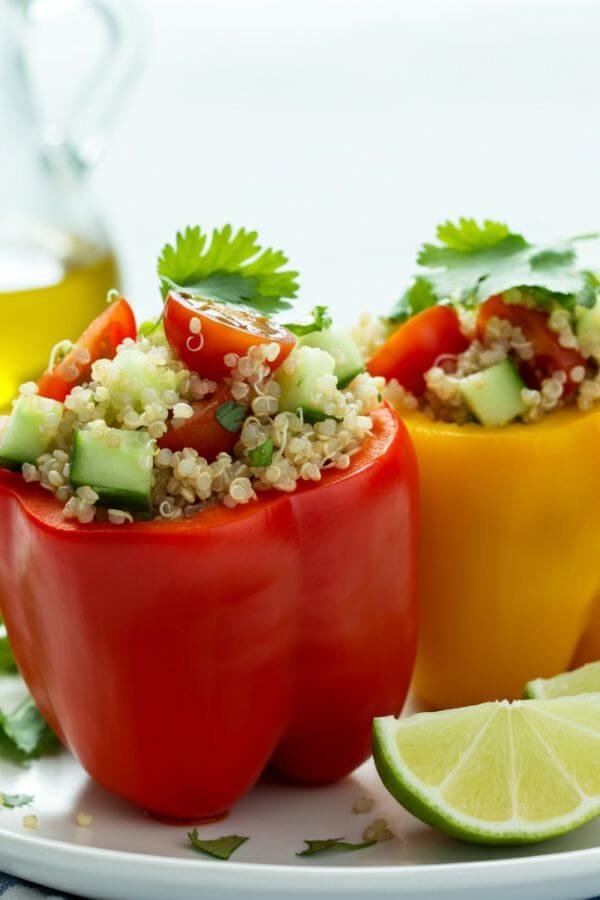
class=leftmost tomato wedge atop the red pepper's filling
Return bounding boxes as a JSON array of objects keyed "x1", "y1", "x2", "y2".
[{"x1": 38, "y1": 297, "x2": 137, "y2": 401}]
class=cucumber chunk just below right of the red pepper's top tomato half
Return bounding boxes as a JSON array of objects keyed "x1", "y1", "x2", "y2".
[{"x1": 276, "y1": 346, "x2": 335, "y2": 422}]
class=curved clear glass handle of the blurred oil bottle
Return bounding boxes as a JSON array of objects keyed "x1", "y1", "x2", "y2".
[{"x1": 29, "y1": 0, "x2": 142, "y2": 176}]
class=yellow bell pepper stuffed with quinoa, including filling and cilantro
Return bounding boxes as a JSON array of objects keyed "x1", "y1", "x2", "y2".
[{"x1": 362, "y1": 219, "x2": 600, "y2": 707}]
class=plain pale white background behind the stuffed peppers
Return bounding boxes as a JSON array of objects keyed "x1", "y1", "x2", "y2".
[{"x1": 36, "y1": 0, "x2": 600, "y2": 318}]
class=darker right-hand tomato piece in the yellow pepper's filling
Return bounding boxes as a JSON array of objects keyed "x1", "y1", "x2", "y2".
[{"x1": 477, "y1": 294, "x2": 586, "y2": 397}]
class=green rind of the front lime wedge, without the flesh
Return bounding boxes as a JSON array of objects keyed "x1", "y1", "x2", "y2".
[{"x1": 373, "y1": 694, "x2": 600, "y2": 846}]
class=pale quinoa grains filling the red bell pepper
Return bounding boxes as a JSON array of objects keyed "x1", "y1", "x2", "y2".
[{"x1": 0, "y1": 327, "x2": 384, "y2": 525}]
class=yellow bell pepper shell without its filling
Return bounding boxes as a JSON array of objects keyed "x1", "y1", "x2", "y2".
[{"x1": 404, "y1": 409, "x2": 600, "y2": 708}]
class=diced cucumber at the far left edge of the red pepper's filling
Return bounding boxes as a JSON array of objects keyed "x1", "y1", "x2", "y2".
[{"x1": 0, "y1": 394, "x2": 64, "y2": 469}]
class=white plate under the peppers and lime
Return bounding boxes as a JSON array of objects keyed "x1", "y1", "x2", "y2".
[{"x1": 0, "y1": 678, "x2": 600, "y2": 900}]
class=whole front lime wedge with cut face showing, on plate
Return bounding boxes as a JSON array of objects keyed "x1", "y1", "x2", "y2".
[{"x1": 373, "y1": 694, "x2": 600, "y2": 844}]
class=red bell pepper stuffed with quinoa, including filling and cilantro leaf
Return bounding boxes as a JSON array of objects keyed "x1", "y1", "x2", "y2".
[{"x1": 0, "y1": 228, "x2": 418, "y2": 819}]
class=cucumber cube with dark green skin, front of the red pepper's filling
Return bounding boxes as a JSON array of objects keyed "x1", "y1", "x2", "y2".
[{"x1": 71, "y1": 428, "x2": 155, "y2": 512}]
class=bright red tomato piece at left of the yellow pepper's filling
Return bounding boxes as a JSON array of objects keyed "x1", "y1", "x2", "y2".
[{"x1": 367, "y1": 306, "x2": 469, "y2": 397}]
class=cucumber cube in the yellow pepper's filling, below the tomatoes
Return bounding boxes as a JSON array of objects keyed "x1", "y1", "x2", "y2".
[{"x1": 459, "y1": 359, "x2": 525, "y2": 428}]
